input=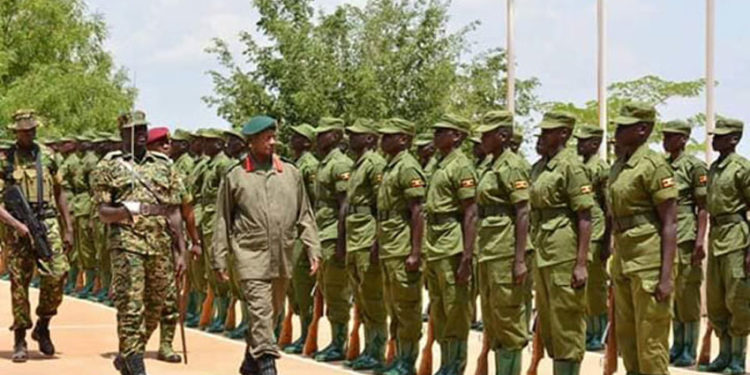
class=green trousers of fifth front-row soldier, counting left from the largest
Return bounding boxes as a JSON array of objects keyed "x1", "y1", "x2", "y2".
[{"x1": 380, "y1": 256, "x2": 424, "y2": 343}]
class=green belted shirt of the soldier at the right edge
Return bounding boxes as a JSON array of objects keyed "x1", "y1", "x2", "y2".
[{"x1": 707, "y1": 153, "x2": 750, "y2": 256}]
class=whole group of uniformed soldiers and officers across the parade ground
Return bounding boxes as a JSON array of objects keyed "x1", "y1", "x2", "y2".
[{"x1": 0, "y1": 103, "x2": 750, "y2": 375}]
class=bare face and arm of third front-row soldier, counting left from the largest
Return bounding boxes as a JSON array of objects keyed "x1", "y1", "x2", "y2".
[{"x1": 482, "y1": 127, "x2": 529, "y2": 285}]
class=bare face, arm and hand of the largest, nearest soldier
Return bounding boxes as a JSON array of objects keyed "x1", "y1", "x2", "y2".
[{"x1": 605, "y1": 123, "x2": 677, "y2": 302}]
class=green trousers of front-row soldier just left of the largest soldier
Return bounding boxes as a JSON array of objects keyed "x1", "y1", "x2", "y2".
[{"x1": 534, "y1": 261, "x2": 586, "y2": 362}]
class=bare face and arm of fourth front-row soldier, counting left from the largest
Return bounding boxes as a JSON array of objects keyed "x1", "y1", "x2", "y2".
[{"x1": 433, "y1": 128, "x2": 479, "y2": 285}]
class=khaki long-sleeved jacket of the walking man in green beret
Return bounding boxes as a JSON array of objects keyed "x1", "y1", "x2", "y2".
[{"x1": 209, "y1": 156, "x2": 320, "y2": 280}]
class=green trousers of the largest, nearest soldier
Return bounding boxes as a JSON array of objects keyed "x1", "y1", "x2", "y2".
[{"x1": 612, "y1": 253, "x2": 674, "y2": 375}]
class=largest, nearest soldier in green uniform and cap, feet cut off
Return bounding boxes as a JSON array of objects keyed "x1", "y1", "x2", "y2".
[{"x1": 605, "y1": 103, "x2": 678, "y2": 374}]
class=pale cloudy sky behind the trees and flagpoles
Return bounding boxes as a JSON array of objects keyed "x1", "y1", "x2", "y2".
[{"x1": 86, "y1": 0, "x2": 750, "y2": 154}]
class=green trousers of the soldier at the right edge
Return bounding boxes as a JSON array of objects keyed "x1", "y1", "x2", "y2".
[{"x1": 706, "y1": 250, "x2": 750, "y2": 337}]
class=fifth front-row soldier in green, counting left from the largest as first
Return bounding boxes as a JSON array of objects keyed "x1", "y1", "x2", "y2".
[{"x1": 376, "y1": 118, "x2": 426, "y2": 375}]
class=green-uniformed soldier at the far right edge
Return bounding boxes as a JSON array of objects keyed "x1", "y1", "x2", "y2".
[{"x1": 700, "y1": 118, "x2": 750, "y2": 375}]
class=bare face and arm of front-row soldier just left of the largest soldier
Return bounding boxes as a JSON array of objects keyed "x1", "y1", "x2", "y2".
[{"x1": 538, "y1": 128, "x2": 591, "y2": 289}]
